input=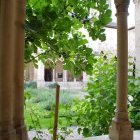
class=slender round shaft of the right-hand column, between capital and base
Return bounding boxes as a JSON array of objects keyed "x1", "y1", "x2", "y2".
[{"x1": 117, "y1": 9, "x2": 128, "y2": 119}]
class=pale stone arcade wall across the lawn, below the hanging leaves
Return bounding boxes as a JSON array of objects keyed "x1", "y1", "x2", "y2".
[{"x1": 37, "y1": 60, "x2": 88, "y2": 89}]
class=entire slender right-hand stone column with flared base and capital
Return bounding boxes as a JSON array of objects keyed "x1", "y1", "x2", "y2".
[{"x1": 109, "y1": 0, "x2": 133, "y2": 140}]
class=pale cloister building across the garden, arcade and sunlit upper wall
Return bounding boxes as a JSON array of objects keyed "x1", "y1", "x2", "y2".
[{"x1": 25, "y1": 22, "x2": 136, "y2": 89}]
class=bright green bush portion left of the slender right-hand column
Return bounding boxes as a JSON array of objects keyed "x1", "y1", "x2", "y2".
[{"x1": 76, "y1": 54, "x2": 116, "y2": 137}]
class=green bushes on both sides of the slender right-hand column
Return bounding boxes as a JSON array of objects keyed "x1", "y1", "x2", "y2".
[{"x1": 75, "y1": 54, "x2": 140, "y2": 137}]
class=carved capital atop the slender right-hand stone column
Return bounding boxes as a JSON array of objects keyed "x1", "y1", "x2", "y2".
[{"x1": 115, "y1": 0, "x2": 130, "y2": 14}]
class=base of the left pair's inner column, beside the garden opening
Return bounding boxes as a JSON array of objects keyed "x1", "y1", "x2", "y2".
[{"x1": 16, "y1": 125, "x2": 28, "y2": 140}]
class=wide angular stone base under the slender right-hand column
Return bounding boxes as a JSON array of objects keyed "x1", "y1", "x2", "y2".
[{"x1": 109, "y1": 119, "x2": 133, "y2": 140}]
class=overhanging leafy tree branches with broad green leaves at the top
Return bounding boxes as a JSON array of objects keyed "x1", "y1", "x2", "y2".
[{"x1": 25, "y1": 0, "x2": 111, "y2": 75}]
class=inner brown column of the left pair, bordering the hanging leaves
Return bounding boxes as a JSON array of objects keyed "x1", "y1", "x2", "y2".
[{"x1": 14, "y1": 0, "x2": 27, "y2": 140}]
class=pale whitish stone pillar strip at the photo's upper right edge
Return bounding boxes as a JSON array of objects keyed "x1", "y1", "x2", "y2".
[{"x1": 134, "y1": 0, "x2": 140, "y2": 77}]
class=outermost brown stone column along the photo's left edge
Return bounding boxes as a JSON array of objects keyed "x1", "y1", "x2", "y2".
[{"x1": 0, "y1": 0, "x2": 16, "y2": 140}]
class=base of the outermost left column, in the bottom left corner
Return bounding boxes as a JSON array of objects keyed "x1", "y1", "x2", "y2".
[{"x1": 0, "y1": 129, "x2": 16, "y2": 140}]
